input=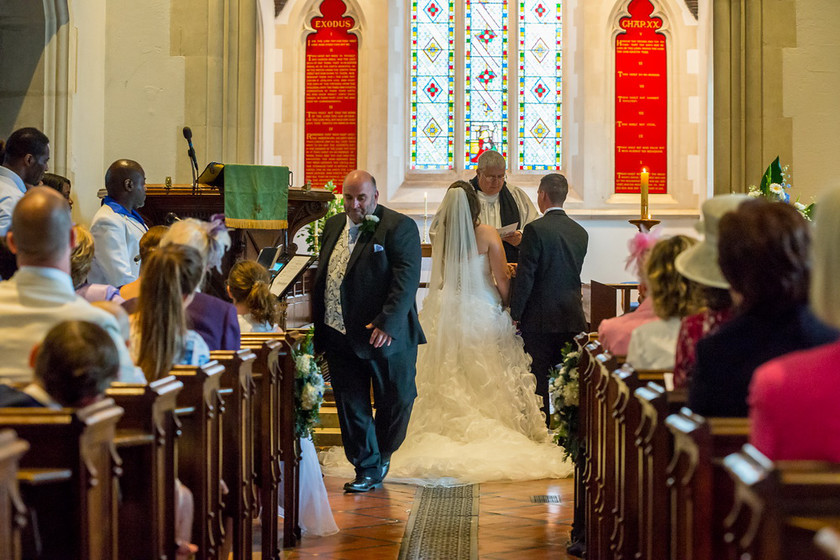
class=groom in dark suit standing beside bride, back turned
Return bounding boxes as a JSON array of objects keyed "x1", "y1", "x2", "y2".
[{"x1": 510, "y1": 173, "x2": 589, "y2": 424}]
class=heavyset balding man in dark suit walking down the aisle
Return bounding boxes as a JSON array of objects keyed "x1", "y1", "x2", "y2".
[{"x1": 312, "y1": 170, "x2": 426, "y2": 492}]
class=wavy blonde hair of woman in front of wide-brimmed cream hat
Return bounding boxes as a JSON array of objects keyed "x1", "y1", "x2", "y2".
[{"x1": 645, "y1": 235, "x2": 702, "y2": 319}]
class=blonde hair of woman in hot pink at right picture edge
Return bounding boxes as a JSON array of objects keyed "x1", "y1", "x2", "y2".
[{"x1": 811, "y1": 188, "x2": 840, "y2": 327}]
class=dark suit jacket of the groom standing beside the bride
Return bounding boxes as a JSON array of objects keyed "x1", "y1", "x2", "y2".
[{"x1": 510, "y1": 210, "x2": 589, "y2": 333}]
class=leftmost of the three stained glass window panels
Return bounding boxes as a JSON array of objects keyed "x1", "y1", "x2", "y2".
[{"x1": 411, "y1": 0, "x2": 455, "y2": 169}]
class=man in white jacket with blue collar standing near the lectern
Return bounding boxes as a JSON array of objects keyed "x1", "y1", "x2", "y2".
[{"x1": 88, "y1": 159, "x2": 149, "y2": 288}]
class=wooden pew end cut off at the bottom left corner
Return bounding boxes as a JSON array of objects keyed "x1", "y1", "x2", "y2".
[{"x1": 0, "y1": 430, "x2": 29, "y2": 560}]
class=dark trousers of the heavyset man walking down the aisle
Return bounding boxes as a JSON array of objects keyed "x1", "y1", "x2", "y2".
[{"x1": 325, "y1": 327, "x2": 417, "y2": 476}]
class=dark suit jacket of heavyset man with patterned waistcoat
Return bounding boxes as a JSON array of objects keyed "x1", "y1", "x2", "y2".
[{"x1": 312, "y1": 205, "x2": 426, "y2": 359}]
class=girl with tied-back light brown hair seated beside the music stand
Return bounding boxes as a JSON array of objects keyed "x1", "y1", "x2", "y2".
[{"x1": 227, "y1": 261, "x2": 280, "y2": 333}]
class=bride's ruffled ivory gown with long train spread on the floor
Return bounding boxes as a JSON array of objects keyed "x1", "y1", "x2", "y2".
[{"x1": 322, "y1": 255, "x2": 573, "y2": 485}]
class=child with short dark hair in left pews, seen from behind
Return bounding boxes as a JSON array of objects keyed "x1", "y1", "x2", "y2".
[{"x1": 0, "y1": 321, "x2": 120, "y2": 408}]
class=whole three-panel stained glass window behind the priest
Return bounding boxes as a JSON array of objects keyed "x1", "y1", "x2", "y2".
[{"x1": 409, "y1": 0, "x2": 563, "y2": 171}]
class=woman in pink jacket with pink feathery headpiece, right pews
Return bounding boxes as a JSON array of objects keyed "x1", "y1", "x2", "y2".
[{"x1": 598, "y1": 232, "x2": 657, "y2": 356}]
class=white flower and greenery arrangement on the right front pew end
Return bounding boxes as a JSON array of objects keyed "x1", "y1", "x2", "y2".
[{"x1": 548, "y1": 343, "x2": 580, "y2": 461}]
